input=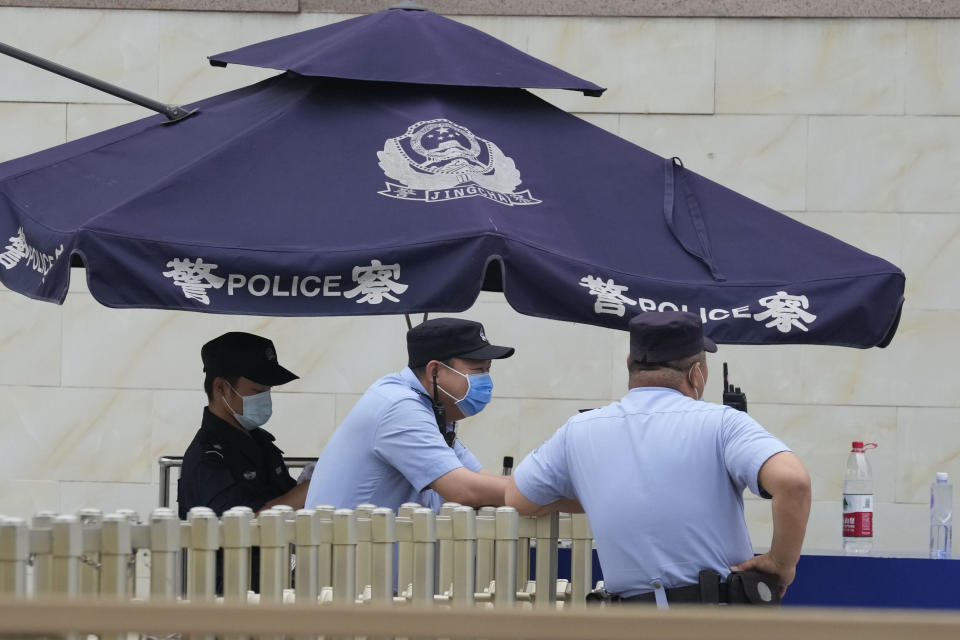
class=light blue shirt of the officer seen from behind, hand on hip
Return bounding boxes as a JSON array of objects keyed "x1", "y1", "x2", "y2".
[{"x1": 514, "y1": 387, "x2": 789, "y2": 596}]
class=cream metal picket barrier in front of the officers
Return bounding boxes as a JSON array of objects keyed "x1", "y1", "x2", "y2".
[{"x1": 0, "y1": 503, "x2": 593, "y2": 609}]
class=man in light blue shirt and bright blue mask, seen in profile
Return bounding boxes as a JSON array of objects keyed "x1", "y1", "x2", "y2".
[{"x1": 306, "y1": 318, "x2": 514, "y2": 509}]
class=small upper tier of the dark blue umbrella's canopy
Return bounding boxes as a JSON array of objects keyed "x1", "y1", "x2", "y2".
[{"x1": 210, "y1": 7, "x2": 604, "y2": 96}]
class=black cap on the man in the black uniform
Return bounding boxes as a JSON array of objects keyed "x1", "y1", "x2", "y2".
[{"x1": 200, "y1": 331, "x2": 298, "y2": 387}]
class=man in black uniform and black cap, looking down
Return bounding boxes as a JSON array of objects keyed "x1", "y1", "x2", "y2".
[{"x1": 177, "y1": 331, "x2": 308, "y2": 518}]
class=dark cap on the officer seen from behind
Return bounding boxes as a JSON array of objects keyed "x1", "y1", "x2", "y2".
[{"x1": 630, "y1": 311, "x2": 717, "y2": 364}]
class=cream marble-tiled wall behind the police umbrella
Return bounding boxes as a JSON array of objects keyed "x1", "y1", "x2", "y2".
[{"x1": 0, "y1": 3, "x2": 960, "y2": 552}]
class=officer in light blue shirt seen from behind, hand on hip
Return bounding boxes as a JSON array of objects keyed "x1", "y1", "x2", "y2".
[{"x1": 507, "y1": 311, "x2": 810, "y2": 605}]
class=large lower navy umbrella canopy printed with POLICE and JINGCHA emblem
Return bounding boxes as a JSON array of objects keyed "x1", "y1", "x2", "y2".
[{"x1": 0, "y1": 7, "x2": 904, "y2": 347}]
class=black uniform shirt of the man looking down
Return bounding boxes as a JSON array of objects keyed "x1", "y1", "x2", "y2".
[{"x1": 177, "y1": 408, "x2": 297, "y2": 519}]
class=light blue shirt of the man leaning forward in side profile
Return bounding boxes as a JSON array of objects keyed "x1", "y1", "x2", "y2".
[{"x1": 306, "y1": 367, "x2": 481, "y2": 511}]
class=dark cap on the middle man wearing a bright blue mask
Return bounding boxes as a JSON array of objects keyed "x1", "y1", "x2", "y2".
[{"x1": 407, "y1": 318, "x2": 514, "y2": 368}]
